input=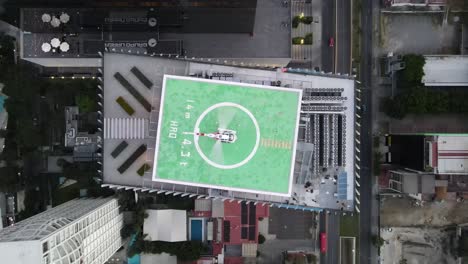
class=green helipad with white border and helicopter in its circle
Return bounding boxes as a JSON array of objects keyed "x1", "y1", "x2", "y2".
[{"x1": 153, "y1": 75, "x2": 301, "y2": 196}]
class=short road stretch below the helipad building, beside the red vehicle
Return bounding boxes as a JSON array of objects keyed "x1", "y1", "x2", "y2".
[{"x1": 318, "y1": 211, "x2": 340, "y2": 264}]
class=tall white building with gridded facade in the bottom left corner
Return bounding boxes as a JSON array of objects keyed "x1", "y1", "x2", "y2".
[{"x1": 0, "y1": 198, "x2": 123, "y2": 264}]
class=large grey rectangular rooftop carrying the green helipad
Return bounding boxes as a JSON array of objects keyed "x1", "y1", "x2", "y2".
[{"x1": 102, "y1": 53, "x2": 354, "y2": 209}]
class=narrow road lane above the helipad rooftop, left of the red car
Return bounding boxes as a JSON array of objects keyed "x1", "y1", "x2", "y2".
[{"x1": 321, "y1": 0, "x2": 335, "y2": 72}]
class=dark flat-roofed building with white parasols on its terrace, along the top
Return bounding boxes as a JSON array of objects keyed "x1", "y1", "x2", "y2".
[{"x1": 20, "y1": 0, "x2": 292, "y2": 69}]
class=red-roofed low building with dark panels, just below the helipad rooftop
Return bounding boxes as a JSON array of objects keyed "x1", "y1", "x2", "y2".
[{"x1": 189, "y1": 199, "x2": 269, "y2": 264}]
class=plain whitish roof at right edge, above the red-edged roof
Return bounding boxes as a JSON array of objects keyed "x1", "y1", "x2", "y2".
[{"x1": 422, "y1": 55, "x2": 468, "y2": 86}]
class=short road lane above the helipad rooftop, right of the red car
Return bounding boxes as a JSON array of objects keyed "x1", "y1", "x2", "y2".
[{"x1": 335, "y1": 0, "x2": 352, "y2": 74}]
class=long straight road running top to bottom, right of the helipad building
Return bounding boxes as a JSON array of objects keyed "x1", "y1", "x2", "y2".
[{"x1": 358, "y1": 0, "x2": 378, "y2": 264}]
